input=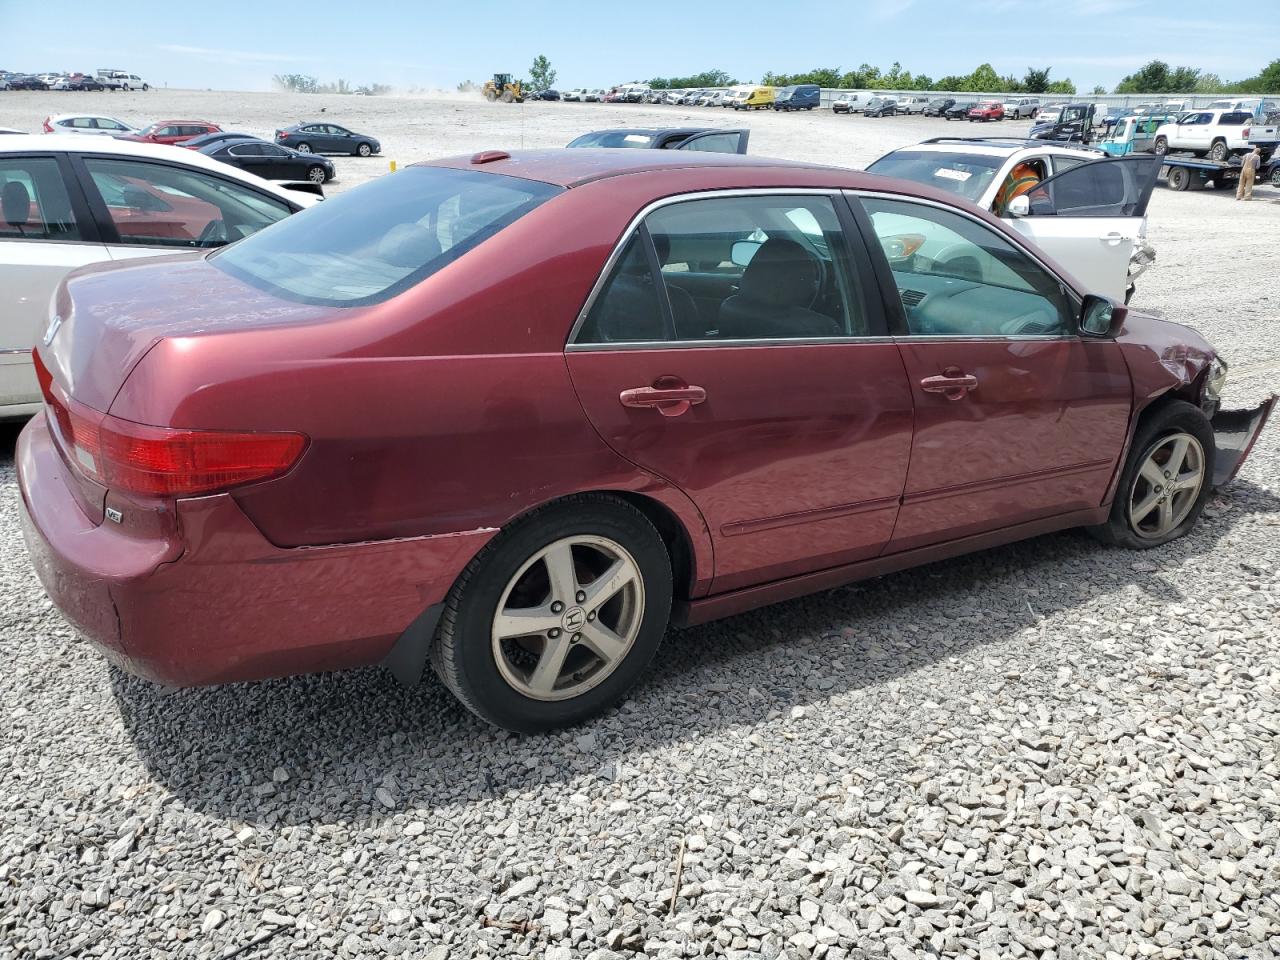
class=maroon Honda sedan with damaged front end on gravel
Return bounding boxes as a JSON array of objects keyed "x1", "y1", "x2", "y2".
[{"x1": 18, "y1": 150, "x2": 1271, "y2": 731}]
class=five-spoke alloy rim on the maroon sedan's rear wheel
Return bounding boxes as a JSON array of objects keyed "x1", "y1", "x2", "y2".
[{"x1": 490, "y1": 535, "x2": 644, "y2": 700}]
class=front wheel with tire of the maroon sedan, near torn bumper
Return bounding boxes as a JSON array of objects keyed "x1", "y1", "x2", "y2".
[{"x1": 1089, "y1": 401, "x2": 1216, "y2": 550}]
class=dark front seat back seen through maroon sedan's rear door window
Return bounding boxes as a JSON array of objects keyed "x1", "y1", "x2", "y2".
[{"x1": 719, "y1": 237, "x2": 842, "y2": 339}]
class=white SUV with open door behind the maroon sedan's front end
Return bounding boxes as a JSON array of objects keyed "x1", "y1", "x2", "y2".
[{"x1": 867, "y1": 137, "x2": 1160, "y2": 302}]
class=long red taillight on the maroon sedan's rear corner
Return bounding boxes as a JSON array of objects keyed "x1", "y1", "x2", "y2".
[{"x1": 44, "y1": 386, "x2": 306, "y2": 497}]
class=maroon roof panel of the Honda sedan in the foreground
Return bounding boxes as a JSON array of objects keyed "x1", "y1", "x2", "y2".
[{"x1": 430, "y1": 147, "x2": 881, "y2": 188}]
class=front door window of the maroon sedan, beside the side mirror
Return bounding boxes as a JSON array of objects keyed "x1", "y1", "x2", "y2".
[{"x1": 863, "y1": 198, "x2": 1074, "y2": 337}]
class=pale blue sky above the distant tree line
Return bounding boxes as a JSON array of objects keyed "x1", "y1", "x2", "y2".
[{"x1": 0, "y1": 0, "x2": 1280, "y2": 90}]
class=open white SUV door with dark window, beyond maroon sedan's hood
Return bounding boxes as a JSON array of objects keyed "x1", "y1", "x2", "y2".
[{"x1": 1007, "y1": 155, "x2": 1161, "y2": 303}]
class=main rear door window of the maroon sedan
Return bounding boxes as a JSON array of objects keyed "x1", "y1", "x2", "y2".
[{"x1": 645, "y1": 196, "x2": 867, "y2": 343}]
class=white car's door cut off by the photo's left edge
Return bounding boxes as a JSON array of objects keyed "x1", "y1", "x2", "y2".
[{"x1": 0, "y1": 154, "x2": 110, "y2": 416}]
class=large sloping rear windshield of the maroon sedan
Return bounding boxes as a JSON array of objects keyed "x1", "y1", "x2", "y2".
[{"x1": 210, "y1": 166, "x2": 561, "y2": 307}]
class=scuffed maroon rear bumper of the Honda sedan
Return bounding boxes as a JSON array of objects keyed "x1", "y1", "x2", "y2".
[{"x1": 17, "y1": 416, "x2": 494, "y2": 686}]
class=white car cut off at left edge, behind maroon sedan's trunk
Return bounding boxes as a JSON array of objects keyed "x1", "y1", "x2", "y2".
[{"x1": 0, "y1": 134, "x2": 323, "y2": 420}]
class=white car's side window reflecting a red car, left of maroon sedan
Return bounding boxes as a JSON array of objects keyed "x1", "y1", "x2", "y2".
[{"x1": 84, "y1": 157, "x2": 292, "y2": 247}]
